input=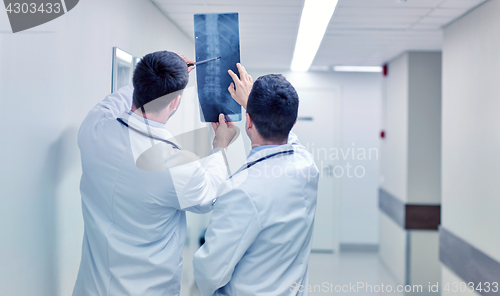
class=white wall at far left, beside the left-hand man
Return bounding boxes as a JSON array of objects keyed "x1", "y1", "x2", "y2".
[{"x1": 0, "y1": 0, "x2": 194, "y2": 296}]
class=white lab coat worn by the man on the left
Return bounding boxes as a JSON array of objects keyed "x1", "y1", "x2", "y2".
[{"x1": 73, "y1": 85, "x2": 227, "y2": 296}]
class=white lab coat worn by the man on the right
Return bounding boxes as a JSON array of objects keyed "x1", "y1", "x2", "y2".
[{"x1": 193, "y1": 133, "x2": 319, "y2": 296}]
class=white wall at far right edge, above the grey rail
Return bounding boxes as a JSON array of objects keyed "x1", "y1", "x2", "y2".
[{"x1": 442, "y1": 1, "x2": 500, "y2": 261}]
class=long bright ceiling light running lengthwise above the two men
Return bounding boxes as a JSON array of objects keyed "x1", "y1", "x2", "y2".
[{"x1": 291, "y1": 0, "x2": 339, "y2": 71}]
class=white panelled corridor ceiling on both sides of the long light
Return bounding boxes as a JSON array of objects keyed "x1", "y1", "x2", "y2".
[{"x1": 151, "y1": 0, "x2": 487, "y2": 70}]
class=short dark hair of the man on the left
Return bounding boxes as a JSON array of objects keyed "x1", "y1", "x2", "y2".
[{"x1": 132, "y1": 51, "x2": 189, "y2": 111}]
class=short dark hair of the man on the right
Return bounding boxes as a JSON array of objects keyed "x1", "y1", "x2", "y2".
[{"x1": 247, "y1": 74, "x2": 299, "y2": 141}]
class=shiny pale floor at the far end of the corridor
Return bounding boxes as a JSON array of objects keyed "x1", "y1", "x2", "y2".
[{"x1": 309, "y1": 251, "x2": 403, "y2": 296}]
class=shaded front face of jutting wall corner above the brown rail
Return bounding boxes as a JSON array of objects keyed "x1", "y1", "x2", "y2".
[{"x1": 407, "y1": 52, "x2": 441, "y2": 204}]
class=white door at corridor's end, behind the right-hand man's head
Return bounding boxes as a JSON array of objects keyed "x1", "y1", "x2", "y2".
[{"x1": 293, "y1": 88, "x2": 340, "y2": 252}]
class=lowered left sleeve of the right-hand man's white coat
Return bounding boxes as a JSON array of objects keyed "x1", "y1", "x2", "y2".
[{"x1": 193, "y1": 188, "x2": 261, "y2": 296}]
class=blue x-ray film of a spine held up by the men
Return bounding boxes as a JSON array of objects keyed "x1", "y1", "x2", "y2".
[{"x1": 194, "y1": 13, "x2": 241, "y2": 122}]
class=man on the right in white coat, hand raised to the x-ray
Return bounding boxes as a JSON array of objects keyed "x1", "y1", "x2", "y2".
[{"x1": 193, "y1": 64, "x2": 319, "y2": 296}]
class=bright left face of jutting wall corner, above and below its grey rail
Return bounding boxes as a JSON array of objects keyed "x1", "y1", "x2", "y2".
[{"x1": 379, "y1": 54, "x2": 409, "y2": 284}]
